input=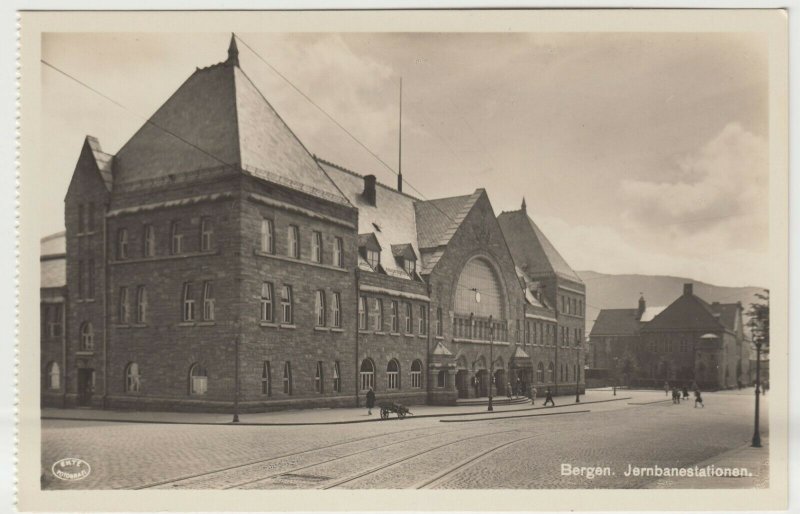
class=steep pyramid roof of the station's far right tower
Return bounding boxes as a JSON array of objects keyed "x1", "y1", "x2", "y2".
[{"x1": 497, "y1": 209, "x2": 583, "y2": 284}]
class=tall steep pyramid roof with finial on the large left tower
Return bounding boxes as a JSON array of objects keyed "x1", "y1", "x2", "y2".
[{"x1": 114, "y1": 42, "x2": 347, "y2": 204}]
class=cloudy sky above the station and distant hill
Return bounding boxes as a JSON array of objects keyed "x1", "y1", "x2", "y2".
[{"x1": 39, "y1": 33, "x2": 769, "y2": 286}]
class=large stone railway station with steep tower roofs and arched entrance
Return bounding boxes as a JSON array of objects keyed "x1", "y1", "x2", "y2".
[{"x1": 41, "y1": 40, "x2": 585, "y2": 412}]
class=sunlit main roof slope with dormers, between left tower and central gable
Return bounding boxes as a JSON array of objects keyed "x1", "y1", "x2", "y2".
[{"x1": 317, "y1": 159, "x2": 419, "y2": 279}]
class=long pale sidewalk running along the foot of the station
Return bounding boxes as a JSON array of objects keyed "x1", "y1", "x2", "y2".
[{"x1": 41, "y1": 390, "x2": 651, "y2": 425}]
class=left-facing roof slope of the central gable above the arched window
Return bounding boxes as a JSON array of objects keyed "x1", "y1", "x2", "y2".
[{"x1": 414, "y1": 189, "x2": 485, "y2": 250}]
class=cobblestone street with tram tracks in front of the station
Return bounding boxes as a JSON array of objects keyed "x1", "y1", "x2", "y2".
[{"x1": 42, "y1": 389, "x2": 769, "y2": 489}]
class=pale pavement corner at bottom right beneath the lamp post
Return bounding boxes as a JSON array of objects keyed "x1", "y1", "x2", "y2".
[{"x1": 644, "y1": 436, "x2": 769, "y2": 489}]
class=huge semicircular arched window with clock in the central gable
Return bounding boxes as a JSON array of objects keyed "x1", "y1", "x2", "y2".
[{"x1": 454, "y1": 257, "x2": 505, "y2": 319}]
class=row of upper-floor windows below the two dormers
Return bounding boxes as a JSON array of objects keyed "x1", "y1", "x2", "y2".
[{"x1": 358, "y1": 296, "x2": 428, "y2": 335}]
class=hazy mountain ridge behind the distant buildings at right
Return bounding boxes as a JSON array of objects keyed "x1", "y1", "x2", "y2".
[{"x1": 577, "y1": 271, "x2": 763, "y2": 334}]
